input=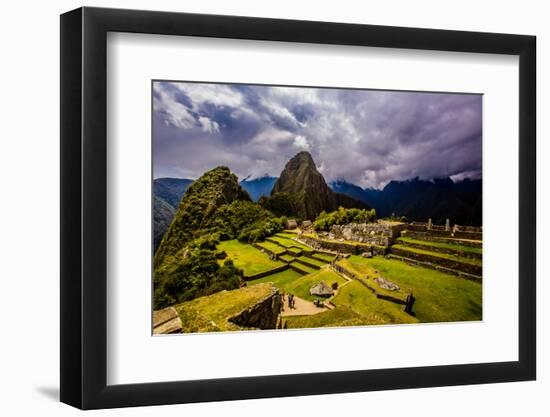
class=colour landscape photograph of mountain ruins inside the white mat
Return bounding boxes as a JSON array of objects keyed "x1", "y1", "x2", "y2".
[{"x1": 151, "y1": 80, "x2": 483, "y2": 335}]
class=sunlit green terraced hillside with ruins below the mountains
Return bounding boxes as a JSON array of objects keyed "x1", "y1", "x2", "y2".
[{"x1": 160, "y1": 226, "x2": 482, "y2": 332}]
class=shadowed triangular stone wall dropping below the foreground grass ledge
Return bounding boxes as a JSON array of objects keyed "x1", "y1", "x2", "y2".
[{"x1": 229, "y1": 290, "x2": 282, "y2": 330}]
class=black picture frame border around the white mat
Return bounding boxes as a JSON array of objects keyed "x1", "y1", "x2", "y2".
[{"x1": 60, "y1": 7, "x2": 536, "y2": 409}]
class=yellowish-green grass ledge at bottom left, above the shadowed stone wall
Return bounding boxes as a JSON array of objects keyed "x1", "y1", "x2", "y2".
[{"x1": 175, "y1": 283, "x2": 273, "y2": 333}]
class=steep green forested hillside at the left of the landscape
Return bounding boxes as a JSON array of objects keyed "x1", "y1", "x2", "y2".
[{"x1": 154, "y1": 167, "x2": 283, "y2": 309}]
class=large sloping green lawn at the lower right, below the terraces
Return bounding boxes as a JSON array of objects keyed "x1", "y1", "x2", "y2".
[{"x1": 347, "y1": 256, "x2": 482, "y2": 322}]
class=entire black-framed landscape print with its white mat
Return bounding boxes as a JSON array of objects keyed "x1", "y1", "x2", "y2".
[{"x1": 61, "y1": 8, "x2": 536, "y2": 409}]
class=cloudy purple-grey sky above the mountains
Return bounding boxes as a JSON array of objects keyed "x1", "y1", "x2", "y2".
[{"x1": 153, "y1": 81, "x2": 482, "y2": 188}]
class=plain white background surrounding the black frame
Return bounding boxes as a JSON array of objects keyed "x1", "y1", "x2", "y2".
[{"x1": 0, "y1": 0, "x2": 550, "y2": 417}]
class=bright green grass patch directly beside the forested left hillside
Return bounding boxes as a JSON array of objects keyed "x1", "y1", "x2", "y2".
[{"x1": 218, "y1": 240, "x2": 283, "y2": 276}]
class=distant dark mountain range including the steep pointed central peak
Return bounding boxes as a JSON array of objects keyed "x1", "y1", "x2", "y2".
[{"x1": 153, "y1": 162, "x2": 482, "y2": 251}]
